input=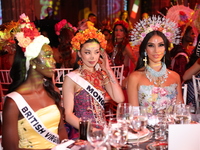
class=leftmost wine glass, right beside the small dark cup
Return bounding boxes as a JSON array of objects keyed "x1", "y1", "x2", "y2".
[{"x1": 87, "y1": 121, "x2": 108, "y2": 150}]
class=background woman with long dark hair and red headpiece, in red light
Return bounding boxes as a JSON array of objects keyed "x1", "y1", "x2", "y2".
[{"x1": 111, "y1": 20, "x2": 136, "y2": 77}]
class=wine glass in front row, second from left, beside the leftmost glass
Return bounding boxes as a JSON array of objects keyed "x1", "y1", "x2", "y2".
[{"x1": 109, "y1": 121, "x2": 128, "y2": 150}]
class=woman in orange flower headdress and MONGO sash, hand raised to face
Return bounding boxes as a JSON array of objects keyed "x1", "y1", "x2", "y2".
[{"x1": 63, "y1": 28, "x2": 124, "y2": 138}]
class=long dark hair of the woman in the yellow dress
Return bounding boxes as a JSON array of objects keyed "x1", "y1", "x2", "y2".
[{"x1": 8, "y1": 41, "x2": 61, "y2": 106}]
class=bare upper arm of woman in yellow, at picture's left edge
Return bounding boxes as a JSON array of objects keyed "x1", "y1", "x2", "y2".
[{"x1": 2, "y1": 97, "x2": 19, "y2": 150}]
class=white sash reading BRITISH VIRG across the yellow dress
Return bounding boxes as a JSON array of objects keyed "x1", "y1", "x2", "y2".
[{"x1": 6, "y1": 92, "x2": 59, "y2": 145}]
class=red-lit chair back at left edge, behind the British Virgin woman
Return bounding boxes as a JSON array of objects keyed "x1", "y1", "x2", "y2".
[{"x1": 0, "y1": 70, "x2": 12, "y2": 110}]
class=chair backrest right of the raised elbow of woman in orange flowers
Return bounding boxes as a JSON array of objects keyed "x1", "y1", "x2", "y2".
[{"x1": 111, "y1": 65, "x2": 124, "y2": 86}]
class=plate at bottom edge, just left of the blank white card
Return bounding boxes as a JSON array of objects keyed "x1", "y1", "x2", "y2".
[{"x1": 146, "y1": 142, "x2": 168, "y2": 150}]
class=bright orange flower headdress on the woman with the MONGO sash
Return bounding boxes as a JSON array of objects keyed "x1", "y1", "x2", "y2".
[{"x1": 71, "y1": 28, "x2": 107, "y2": 51}]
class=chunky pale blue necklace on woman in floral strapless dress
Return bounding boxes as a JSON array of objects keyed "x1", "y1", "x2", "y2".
[{"x1": 145, "y1": 63, "x2": 168, "y2": 86}]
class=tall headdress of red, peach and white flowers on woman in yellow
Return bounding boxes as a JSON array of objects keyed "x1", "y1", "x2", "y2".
[{"x1": 15, "y1": 13, "x2": 50, "y2": 74}]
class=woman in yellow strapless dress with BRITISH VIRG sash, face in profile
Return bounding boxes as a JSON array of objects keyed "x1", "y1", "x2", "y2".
[{"x1": 2, "y1": 14, "x2": 68, "y2": 150}]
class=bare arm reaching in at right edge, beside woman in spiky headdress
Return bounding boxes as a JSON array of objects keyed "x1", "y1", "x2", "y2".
[{"x1": 183, "y1": 58, "x2": 200, "y2": 81}]
